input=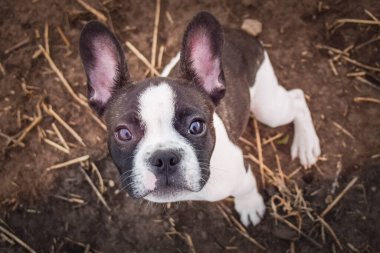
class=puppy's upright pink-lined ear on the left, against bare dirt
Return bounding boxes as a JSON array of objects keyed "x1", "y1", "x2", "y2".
[{"x1": 79, "y1": 21, "x2": 129, "y2": 115}]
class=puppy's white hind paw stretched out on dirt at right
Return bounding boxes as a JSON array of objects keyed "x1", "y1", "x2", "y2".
[{"x1": 291, "y1": 123, "x2": 321, "y2": 168}]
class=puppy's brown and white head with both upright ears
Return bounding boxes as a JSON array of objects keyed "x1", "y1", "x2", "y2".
[{"x1": 80, "y1": 12, "x2": 225, "y2": 202}]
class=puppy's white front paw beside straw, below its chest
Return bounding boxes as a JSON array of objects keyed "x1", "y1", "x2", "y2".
[{"x1": 235, "y1": 192, "x2": 265, "y2": 227}]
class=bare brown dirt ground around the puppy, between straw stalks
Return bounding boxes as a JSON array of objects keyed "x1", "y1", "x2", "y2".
[{"x1": 0, "y1": 0, "x2": 380, "y2": 252}]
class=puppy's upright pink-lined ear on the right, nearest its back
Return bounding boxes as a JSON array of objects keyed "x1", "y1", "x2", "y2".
[{"x1": 180, "y1": 12, "x2": 226, "y2": 104}]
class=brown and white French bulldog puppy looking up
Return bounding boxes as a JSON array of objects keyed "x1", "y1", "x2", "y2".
[{"x1": 79, "y1": 12, "x2": 320, "y2": 226}]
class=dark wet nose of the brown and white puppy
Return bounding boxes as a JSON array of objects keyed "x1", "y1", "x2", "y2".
[{"x1": 150, "y1": 150, "x2": 181, "y2": 175}]
